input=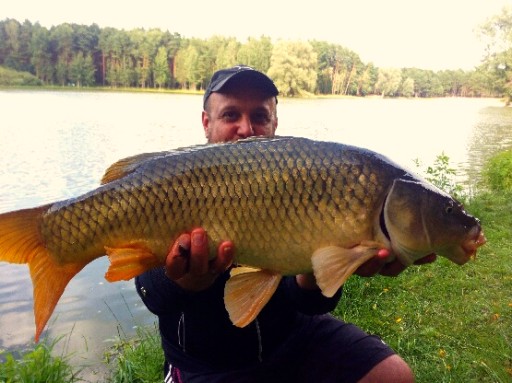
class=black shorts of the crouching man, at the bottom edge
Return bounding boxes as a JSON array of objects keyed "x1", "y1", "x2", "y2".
[{"x1": 168, "y1": 315, "x2": 395, "y2": 383}]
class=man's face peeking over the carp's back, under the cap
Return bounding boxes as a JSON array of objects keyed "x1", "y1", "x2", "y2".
[{"x1": 202, "y1": 89, "x2": 277, "y2": 143}]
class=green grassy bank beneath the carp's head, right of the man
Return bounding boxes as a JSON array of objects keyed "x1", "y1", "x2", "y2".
[{"x1": 335, "y1": 193, "x2": 512, "y2": 383}]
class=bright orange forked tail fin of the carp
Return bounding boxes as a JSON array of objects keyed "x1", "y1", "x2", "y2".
[{"x1": 0, "y1": 205, "x2": 85, "y2": 342}]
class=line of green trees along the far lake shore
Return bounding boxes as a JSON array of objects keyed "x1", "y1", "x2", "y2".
[{"x1": 0, "y1": 19, "x2": 505, "y2": 97}]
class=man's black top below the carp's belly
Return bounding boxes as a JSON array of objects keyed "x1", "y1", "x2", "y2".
[{"x1": 135, "y1": 268, "x2": 341, "y2": 371}]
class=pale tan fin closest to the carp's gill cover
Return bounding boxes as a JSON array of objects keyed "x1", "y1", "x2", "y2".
[{"x1": 311, "y1": 243, "x2": 382, "y2": 297}]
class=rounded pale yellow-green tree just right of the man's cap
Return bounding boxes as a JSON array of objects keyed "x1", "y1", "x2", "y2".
[{"x1": 268, "y1": 41, "x2": 317, "y2": 97}]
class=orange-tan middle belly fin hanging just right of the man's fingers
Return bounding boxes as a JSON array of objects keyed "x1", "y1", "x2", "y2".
[{"x1": 224, "y1": 267, "x2": 282, "y2": 327}]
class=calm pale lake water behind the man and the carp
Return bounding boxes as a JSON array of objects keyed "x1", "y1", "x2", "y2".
[{"x1": 0, "y1": 91, "x2": 512, "y2": 380}]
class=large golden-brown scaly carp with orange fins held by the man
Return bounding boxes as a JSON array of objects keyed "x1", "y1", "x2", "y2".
[{"x1": 0, "y1": 137, "x2": 485, "y2": 341}]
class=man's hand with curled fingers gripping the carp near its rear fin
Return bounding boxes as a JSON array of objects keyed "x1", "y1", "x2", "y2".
[{"x1": 165, "y1": 228, "x2": 233, "y2": 291}]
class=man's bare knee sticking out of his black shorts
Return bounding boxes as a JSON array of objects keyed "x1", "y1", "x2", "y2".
[{"x1": 359, "y1": 355, "x2": 414, "y2": 383}]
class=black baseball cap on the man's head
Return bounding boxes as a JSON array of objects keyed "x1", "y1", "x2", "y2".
[{"x1": 203, "y1": 65, "x2": 279, "y2": 107}]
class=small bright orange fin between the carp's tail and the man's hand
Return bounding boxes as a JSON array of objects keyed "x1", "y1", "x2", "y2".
[{"x1": 105, "y1": 243, "x2": 162, "y2": 282}]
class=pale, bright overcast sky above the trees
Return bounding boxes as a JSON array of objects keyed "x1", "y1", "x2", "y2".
[{"x1": 0, "y1": 0, "x2": 512, "y2": 70}]
